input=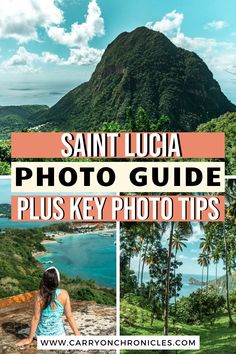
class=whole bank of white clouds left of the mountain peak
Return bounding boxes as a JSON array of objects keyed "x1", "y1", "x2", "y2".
[{"x1": 0, "y1": 0, "x2": 105, "y2": 68}]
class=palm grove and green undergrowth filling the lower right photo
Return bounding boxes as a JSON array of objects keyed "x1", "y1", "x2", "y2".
[{"x1": 121, "y1": 180, "x2": 236, "y2": 353}]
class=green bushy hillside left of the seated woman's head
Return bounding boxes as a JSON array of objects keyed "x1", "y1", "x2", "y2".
[{"x1": 0, "y1": 229, "x2": 45, "y2": 297}]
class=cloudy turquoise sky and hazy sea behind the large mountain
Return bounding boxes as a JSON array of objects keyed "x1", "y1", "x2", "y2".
[{"x1": 0, "y1": 0, "x2": 236, "y2": 106}]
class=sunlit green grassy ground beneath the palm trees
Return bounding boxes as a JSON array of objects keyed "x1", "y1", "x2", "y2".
[{"x1": 121, "y1": 302, "x2": 236, "y2": 354}]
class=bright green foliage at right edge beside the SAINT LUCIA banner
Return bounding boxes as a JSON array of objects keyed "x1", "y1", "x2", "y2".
[{"x1": 197, "y1": 113, "x2": 236, "y2": 175}]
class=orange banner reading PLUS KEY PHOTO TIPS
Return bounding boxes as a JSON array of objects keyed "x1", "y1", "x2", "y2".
[{"x1": 11, "y1": 195, "x2": 224, "y2": 222}]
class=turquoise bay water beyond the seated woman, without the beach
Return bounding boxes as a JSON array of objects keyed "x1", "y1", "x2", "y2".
[{"x1": 38, "y1": 233, "x2": 116, "y2": 288}]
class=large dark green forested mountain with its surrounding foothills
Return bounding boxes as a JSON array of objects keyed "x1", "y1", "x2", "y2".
[{"x1": 0, "y1": 27, "x2": 236, "y2": 175}]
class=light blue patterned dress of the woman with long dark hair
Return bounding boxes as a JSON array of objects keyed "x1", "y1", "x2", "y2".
[{"x1": 36, "y1": 289, "x2": 66, "y2": 336}]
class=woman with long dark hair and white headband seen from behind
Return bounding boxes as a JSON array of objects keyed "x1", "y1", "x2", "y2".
[{"x1": 17, "y1": 267, "x2": 79, "y2": 347}]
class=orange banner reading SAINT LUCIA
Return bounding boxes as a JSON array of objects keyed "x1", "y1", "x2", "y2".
[{"x1": 11, "y1": 132, "x2": 225, "y2": 158}]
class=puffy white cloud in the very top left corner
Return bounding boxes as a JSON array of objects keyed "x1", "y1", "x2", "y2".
[{"x1": 0, "y1": 0, "x2": 63, "y2": 43}]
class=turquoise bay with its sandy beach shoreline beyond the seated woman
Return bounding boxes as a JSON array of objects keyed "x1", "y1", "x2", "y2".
[{"x1": 33, "y1": 228, "x2": 116, "y2": 289}]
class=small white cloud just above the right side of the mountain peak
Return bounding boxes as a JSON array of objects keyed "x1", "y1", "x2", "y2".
[{"x1": 146, "y1": 10, "x2": 184, "y2": 34}]
